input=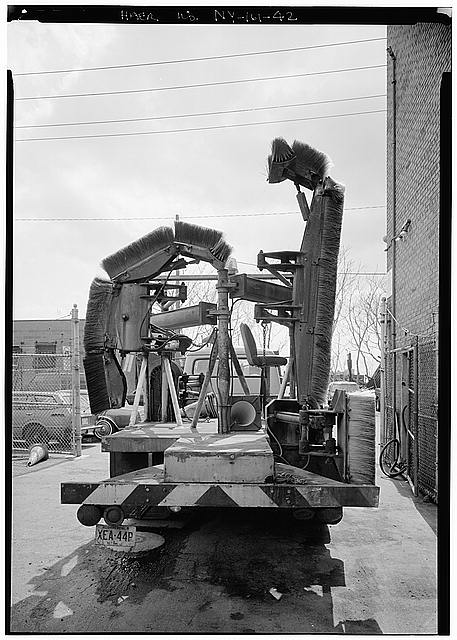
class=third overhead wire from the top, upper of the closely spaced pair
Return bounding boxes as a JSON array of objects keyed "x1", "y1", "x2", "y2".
[{"x1": 15, "y1": 93, "x2": 387, "y2": 129}]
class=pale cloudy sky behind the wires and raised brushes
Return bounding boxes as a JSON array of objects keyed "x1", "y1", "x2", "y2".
[{"x1": 8, "y1": 22, "x2": 386, "y2": 319}]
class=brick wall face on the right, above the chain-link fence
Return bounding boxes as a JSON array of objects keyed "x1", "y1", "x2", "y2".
[{"x1": 387, "y1": 23, "x2": 451, "y2": 345}]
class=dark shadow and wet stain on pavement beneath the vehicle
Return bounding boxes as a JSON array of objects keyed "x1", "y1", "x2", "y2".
[{"x1": 11, "y1": 509, "x2": 381, "y2": 634}]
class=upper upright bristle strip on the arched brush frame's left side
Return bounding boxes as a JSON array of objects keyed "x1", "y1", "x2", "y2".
[{"x1": 83, "y1": 278, "x2": 113, "y2": 353}]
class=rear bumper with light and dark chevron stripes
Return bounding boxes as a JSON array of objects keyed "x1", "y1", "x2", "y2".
[{"x1": 61, "y1": 467, "x2": 379, "y2": 515}]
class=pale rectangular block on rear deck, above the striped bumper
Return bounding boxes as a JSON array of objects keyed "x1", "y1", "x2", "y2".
[{"x1": 164, "y1": 432, "x2": 273, "y2": 483}]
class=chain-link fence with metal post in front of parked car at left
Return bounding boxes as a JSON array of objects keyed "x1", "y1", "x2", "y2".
[{"x1": 11, "y1": 310, "x2": 87, "y2": 455}]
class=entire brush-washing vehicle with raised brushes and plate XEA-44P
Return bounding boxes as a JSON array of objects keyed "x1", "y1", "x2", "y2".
[{"x1": 61, "y1": 138, "x2": 379, "y2": 548}]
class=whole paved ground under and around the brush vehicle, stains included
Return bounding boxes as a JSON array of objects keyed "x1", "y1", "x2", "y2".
[{"x1": 11, "y1": 430, "x2": 437, "y2": 634}]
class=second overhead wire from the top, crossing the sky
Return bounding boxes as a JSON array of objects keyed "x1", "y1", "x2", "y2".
[{"x1": 16, "y1": 64, "x2": 387, "y2": 102}]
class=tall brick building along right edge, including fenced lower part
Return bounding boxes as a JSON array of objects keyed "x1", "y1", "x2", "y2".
[{"x1": 383, "y1": 16, "x2": 451, "y2": 500}]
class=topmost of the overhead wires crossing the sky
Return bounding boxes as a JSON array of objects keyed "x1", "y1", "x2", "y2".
[{"x1": 14, "y1": 37, "x2": 387, "y2": 76}]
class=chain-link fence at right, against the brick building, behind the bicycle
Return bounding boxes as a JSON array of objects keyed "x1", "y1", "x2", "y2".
[{"x1": 383, "y1": 322, "x2": 438, "y2": 502}]
